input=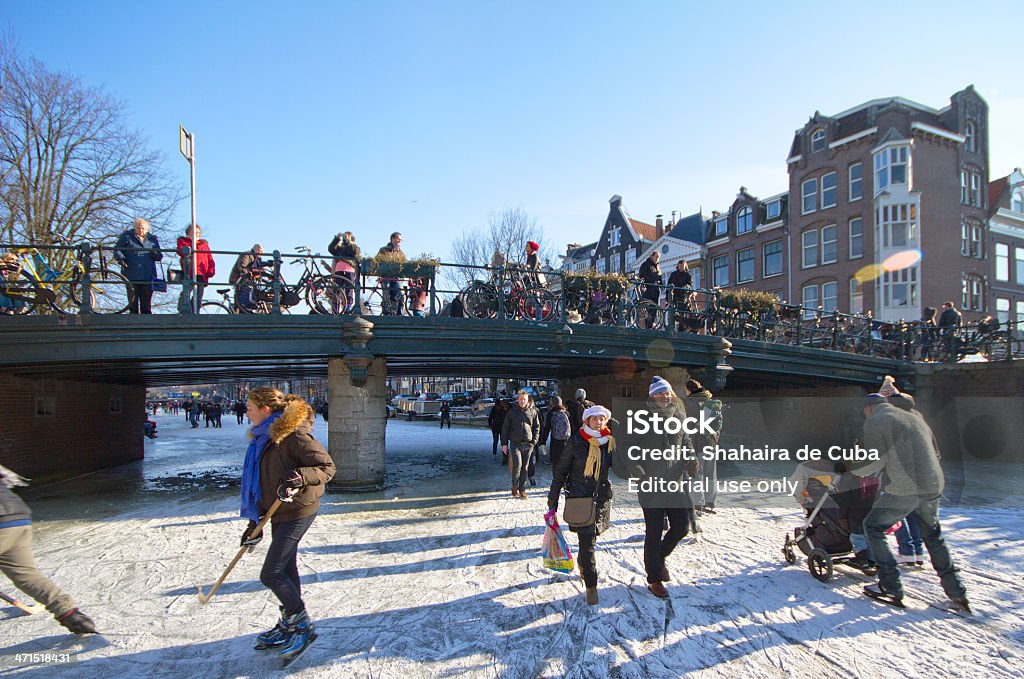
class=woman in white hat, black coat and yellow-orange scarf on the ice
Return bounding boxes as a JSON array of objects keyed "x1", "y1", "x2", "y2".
[{"x1": 548, "y1": 406, "x2": 615, "y2": 606}]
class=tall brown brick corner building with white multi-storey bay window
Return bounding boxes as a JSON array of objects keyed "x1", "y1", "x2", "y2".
[{"x1": 786, "y1": 86, "x2": 989, "y2": 321}]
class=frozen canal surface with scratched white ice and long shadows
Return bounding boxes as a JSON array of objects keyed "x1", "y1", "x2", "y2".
[{"x1": 0, "y1": 416, "x2": 1024, "y2": 679}]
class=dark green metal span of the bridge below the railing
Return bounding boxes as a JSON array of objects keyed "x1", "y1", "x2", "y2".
[{"x1": 0, "y1": 314, "x2": 913, "y2": 386}]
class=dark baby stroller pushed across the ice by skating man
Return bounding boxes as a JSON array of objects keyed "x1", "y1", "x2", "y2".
[{"x1": 782, "y1": 468, "x2": 878, "y2": 583}]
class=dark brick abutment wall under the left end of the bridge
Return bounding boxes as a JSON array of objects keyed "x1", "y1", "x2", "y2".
[{"x1": 0, "y1": 374, "x2": 145, "y2": 482}]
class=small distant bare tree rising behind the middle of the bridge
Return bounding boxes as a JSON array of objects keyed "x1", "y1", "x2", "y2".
[{"x1": 444, "y1": 206, "x2": 550, "y2": 290}]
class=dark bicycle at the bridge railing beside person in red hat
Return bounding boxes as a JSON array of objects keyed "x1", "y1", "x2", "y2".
[{"x1": 460, "y1": 265, "x2": 558, "y2": 321}]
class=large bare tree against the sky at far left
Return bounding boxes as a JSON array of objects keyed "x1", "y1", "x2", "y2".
[{"x1": 0, "y1": 38, "x2": 183, "y2": 268}]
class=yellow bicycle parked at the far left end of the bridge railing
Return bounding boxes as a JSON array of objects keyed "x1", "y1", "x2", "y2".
[{"x1": 0, "y1": 237, "x2": 131, "y2": 314}]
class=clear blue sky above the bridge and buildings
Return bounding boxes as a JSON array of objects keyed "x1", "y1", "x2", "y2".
[{"x1": 8, "y1": 0, "x2": 1024, "y2": 270}]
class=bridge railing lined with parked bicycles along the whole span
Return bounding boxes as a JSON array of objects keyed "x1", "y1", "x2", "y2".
[{"x1": 0, "y1": 241, "x2": 1024, "y2": 362}]
